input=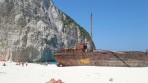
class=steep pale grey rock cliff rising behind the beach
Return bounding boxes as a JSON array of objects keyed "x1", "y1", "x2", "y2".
[{"x1": 0, "y1": 0, "x2": 90, "y2": 61}]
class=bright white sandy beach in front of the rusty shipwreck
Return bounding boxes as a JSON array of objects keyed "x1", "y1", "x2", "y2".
[{"x1": 0, "y1": 62, "x2": 148, "y2": 83}]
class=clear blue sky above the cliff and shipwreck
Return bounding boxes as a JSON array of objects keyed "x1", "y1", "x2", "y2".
[{"x1": 53, "y1": 0, "x2": 148, "y2": 51}]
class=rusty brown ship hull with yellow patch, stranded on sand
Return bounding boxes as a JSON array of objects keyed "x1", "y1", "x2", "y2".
[{"x1": 55, "y1": 51, "x2": 148, "y2": 67}]
